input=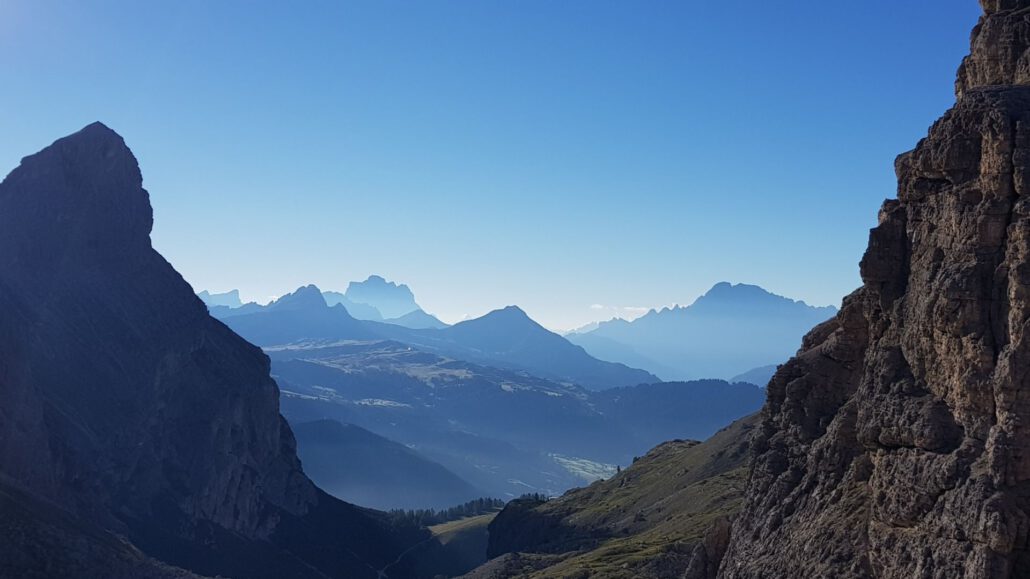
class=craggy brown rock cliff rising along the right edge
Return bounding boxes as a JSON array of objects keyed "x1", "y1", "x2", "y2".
[{"x1": 719, "y1": 0, "x2": 1030, "y2": 579}]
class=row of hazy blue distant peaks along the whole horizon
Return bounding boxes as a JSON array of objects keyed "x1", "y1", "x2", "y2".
[{"x1": 198, "y1": 275, "x2": 836, "y2": 383}]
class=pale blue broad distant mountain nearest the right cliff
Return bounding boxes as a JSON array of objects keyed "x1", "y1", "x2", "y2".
[{"x1": 567, "y1": 282, "x2": 836, "y2": 385}]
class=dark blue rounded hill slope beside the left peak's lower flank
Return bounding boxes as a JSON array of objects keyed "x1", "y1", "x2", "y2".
[{"x1": 293, "y1": 419, "x2": 484, "y2": 510}]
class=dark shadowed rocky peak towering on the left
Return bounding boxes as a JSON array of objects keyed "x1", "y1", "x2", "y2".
[{"x1": 0, "y1": 124, "x2": 438, "y2": 577}]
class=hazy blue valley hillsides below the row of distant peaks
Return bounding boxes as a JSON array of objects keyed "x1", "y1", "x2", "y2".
[{"x1": 267, "y1": 340, "x2": 762, "y2": 497}]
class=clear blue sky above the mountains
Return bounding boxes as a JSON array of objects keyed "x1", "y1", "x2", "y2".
[{"x1": 0, "y1": 0, "x2": 979, "y2": 329}]
